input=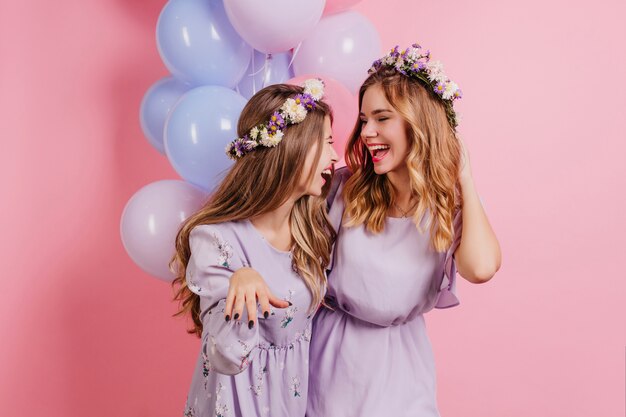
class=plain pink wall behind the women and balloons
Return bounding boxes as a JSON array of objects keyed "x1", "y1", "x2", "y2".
[{"x1": 0, "y1": 0, "x2": 626, "y2": 417}]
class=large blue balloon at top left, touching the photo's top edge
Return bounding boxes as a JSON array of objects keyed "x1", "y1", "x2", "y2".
[{"x1": 156, "y1": 0, "x2": 252, "y2": 88}]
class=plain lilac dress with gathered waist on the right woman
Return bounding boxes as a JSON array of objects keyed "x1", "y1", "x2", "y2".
[{"x1": 307, "y1": 170, "x2": 461, "y2": 417}]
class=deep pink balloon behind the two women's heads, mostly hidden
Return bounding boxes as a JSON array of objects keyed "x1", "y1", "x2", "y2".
[{"x1": 287, "y1": 74, "x2": 359, "y2": 162}]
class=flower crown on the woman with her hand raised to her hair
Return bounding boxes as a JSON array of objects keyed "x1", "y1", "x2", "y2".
[{"x1": 368, "y1": 43, "x2": 463, "y2": 128}]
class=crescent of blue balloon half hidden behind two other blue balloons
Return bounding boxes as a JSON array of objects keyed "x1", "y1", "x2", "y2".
[{"x1": 139, "y1": 77, "x2": 191, "y2": 155}]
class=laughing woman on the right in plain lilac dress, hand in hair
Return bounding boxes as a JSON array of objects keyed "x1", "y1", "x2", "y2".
[{"x1": 224, "y1": 45, "x2": 501, "y2": 417}]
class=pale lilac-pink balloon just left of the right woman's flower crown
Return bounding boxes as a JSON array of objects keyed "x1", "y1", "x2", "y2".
[{"x1": 293, "y1": 11, "x2": 381, "y2": 94}]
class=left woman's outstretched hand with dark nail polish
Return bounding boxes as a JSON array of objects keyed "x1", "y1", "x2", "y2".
[{"x1": 224, "y1": 268, "x2": 291, "y2": 328}]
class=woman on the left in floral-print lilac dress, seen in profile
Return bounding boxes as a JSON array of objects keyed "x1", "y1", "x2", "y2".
[{"x1": 171, "y1": 80, "x2": 337, "y2": 417}]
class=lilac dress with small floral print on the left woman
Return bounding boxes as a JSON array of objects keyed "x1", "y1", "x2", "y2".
[{"x1": 184, "y1": 221, "x2": 312, "y2": 417}]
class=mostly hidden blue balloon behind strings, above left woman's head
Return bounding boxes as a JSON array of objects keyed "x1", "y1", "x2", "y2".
[{"x1": 237, "y1": 51, "x2": 293, "y2": 99}]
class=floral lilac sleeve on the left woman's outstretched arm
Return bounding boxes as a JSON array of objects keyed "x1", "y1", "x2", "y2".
[{"x1": 187, "y1": 225, "x2": 259, "y2": 375}]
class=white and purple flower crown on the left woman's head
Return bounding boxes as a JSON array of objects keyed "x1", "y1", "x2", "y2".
[{"x1": 226, "y1": 78, "x2": 324, "y2": 160}]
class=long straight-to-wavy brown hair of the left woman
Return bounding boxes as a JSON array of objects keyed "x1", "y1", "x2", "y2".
[{"x1": 170, "y1": 84, "x2": 335, "y2": 336}]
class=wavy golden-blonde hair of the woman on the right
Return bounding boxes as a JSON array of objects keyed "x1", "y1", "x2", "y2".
[{"x1": 343, "y1": 68, "x2": 462, "y2": 252}]
